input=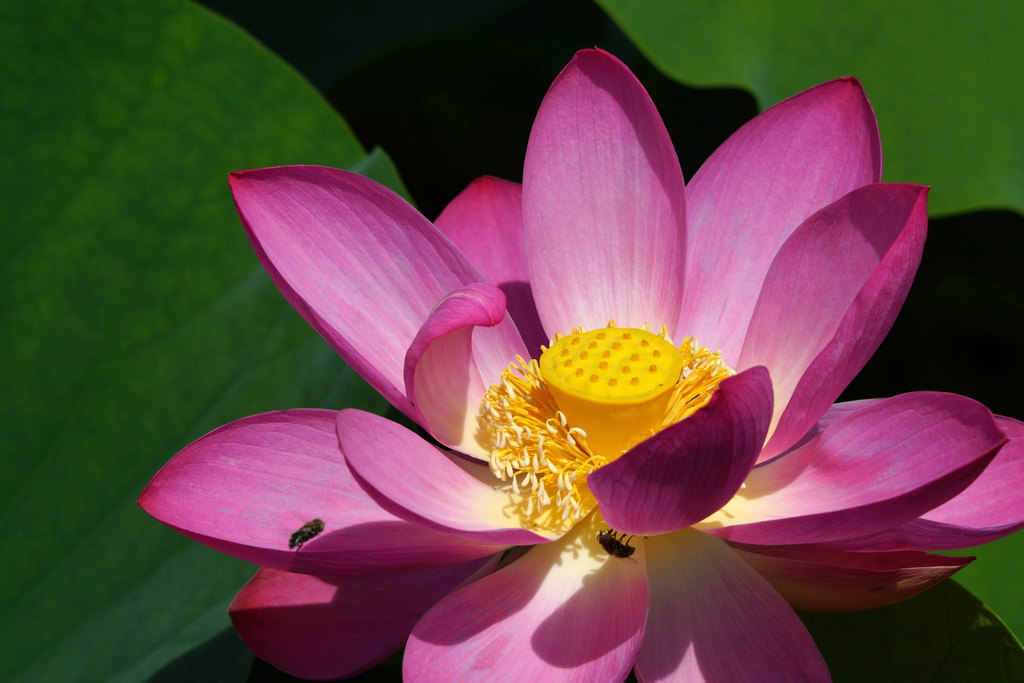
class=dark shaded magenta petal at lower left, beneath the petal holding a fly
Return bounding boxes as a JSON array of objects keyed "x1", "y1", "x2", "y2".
[{"x1": 228, "y1": 560, "x2": 486, "y2": 680}]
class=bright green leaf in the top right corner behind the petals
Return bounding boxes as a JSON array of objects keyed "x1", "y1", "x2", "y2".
[{"x1": 597, "y1": 0, "x2": 1024, "y2": 213}]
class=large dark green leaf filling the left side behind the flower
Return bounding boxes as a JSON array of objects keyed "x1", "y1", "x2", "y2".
[{"x1": 0, "y1": 0, "x2": 387, "y2": 681}]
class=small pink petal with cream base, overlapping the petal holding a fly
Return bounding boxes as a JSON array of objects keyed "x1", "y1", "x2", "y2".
[{"x1": 337, "y1": 410, "x2": 550, "y2": 546}]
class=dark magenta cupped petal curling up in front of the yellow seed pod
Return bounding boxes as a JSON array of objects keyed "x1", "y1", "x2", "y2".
[{"x1": 587, "y1": 368, "x2": 772, "y2": 536}]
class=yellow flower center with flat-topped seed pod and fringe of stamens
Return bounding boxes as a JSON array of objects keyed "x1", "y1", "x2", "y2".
[{"x1": 479, "y1": 322, "x2": 733, "y2": 530}]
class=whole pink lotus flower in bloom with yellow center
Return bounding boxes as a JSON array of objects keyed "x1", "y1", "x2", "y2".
[{"x1": 140, "y1": 50, "x2": 1024, "y2": 681}]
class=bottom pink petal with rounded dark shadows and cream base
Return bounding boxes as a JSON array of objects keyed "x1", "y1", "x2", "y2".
[{"x1": 403, "y1": 515, "x2": 647, "y2": 682}]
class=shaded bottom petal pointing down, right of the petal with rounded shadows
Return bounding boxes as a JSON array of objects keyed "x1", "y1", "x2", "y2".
[{"x1": 636, "y1": 529, "x2": 829, "y2": 683}]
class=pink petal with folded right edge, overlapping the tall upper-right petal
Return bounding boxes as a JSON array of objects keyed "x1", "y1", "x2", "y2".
[{"x1": 739, "y1": 184, "x2": 928, "y2": 460}]
